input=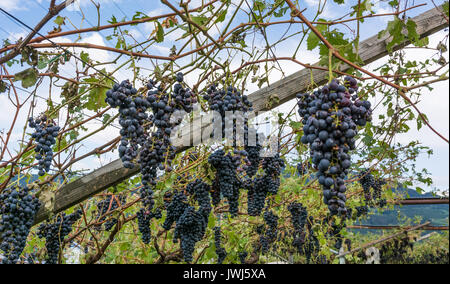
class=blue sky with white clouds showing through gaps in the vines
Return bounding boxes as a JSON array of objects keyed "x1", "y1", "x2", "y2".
[{"x1": 0, "y1": 0, "x2": 449, "y2": 192}]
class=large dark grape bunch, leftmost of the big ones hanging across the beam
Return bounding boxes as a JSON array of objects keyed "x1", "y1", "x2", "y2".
[{"x1": 105, "y1": 80, "x2": 150, "y2": 169}]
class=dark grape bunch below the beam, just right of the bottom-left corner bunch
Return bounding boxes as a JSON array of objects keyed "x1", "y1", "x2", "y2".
[{"x1": 37, "y1": 210, "x2": 82, "y2": 264}]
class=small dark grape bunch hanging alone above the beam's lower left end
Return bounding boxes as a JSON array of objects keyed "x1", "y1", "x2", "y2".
[{"x1": 28, "y1": 115, "x2": 60, "y2": 176}]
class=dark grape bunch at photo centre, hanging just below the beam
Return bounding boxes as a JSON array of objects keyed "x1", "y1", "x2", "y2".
[{"x1": 208, "y1": 149, "x2": 241, "y2": 216}]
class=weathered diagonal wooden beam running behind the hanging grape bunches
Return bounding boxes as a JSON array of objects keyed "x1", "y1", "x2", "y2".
[{"x1": 31, "y1": 7, "x2": 448, "y2": 224}]
